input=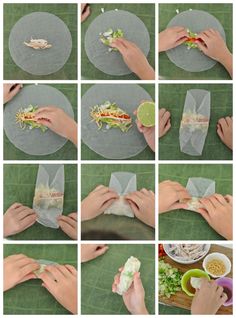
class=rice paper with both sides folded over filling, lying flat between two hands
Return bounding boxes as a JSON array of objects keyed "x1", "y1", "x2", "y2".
[{"x1": 179, "y1": 89, "x2": 211, "y2": 156}]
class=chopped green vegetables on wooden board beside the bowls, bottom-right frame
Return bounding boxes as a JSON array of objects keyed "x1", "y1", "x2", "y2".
[{"x1": 158, "y1": 260, "x2": 182, "y2": 298}]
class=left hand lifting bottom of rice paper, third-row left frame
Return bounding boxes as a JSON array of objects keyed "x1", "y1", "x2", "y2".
[{"x1": 3, "y1": 203, "x2": 37, "y2": 237}]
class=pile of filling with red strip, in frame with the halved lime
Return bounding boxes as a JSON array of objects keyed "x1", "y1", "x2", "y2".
[{"x1": 90, "y1": 101, "x2": 132, "y2": 132}]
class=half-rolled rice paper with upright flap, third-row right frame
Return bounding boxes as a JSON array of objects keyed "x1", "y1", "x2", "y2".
[{"x1": 183, "y1": 178, "x2": 215, "y2": 212}]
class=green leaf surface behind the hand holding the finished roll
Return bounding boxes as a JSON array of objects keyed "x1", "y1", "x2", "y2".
[{"x1": 81, "y1": 244, "x2": 155, "y2": 315}]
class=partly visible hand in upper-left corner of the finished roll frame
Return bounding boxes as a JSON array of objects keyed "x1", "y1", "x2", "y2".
[{"x1": 81, "y1": 244, "x2": 109, "y2": 263}]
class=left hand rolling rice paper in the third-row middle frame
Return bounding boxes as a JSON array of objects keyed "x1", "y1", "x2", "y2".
[{"x1": 81, "y1": 185, "x2": 119, "y2": 221}]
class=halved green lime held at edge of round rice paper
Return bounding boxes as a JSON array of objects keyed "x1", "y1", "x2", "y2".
[{"x1": 137, "y1": 101, "x2": 155, "y2": 127}]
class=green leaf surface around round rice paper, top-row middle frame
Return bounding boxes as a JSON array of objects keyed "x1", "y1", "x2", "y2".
[{"x1": 81, "y1": 3, "x2": 155, "y2": 80}]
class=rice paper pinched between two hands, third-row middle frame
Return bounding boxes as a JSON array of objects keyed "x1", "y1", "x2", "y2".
[{"x1": 104, "y1": 172, "x2": 137, "y2": 218}]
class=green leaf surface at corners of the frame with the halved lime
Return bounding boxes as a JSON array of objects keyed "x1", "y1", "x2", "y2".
[{"x1": 81, "y1": 84, "x2": 155, "y2": 160}]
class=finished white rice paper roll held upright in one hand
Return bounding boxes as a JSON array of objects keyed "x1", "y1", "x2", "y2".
[{"x1": 116, "y1": 256, "x2": 141, "y2": 295}]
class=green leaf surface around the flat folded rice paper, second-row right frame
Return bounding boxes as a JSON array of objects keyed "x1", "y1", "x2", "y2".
[{"x1": 159, "y1": 84, "x2": 233, "y2": 160}]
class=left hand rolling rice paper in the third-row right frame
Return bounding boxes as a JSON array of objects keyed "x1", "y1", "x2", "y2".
[{"x1": 159, "y1": 180, "x2": 191, "y2": 213}]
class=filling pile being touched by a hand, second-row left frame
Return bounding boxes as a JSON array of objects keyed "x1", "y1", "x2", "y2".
[{"x1": 16, "y1": 105, "x2": 48, "y2": 132}]
